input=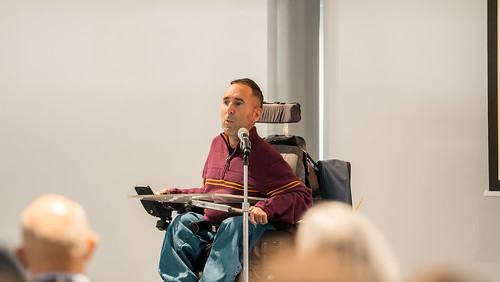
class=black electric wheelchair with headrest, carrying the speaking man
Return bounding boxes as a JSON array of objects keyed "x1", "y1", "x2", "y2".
[{"x1": 135, "y1": 103, "x2": 352, "y2": 281}]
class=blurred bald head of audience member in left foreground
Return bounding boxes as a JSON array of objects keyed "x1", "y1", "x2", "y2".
[{"x1": 17, "y1": 194, "x2": 98, "y2": 276}]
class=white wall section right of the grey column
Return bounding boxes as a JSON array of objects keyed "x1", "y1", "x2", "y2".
[{"x1": 325, "y1": 0, "x2": 500, "y2": 281}]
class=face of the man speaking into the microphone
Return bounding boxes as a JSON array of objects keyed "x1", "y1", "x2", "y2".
[{"x1": 220, "y1": 83, "x2": 262, "y2": 139}]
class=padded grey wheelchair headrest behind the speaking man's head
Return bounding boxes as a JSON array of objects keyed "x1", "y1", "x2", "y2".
[{"x1": 257, "y1": 102, "x2": 301, "y2": 123}]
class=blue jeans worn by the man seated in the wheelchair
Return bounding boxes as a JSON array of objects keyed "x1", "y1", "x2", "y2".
[{"x1": 158, "y1": 212, "x2": 276, "y2": 282}]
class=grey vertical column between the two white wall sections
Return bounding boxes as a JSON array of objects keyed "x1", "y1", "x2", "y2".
[{"x1": 267, "y1": 0, "x2": 320, "y2": 160}]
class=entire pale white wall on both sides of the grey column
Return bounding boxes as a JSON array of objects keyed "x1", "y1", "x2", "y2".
[{"x1": 0, "y1": 0, "x2": 500, "y2": 281}]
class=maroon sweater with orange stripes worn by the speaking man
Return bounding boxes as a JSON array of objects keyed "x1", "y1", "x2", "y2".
[{"x1": 170, "y1": 127, "x2": 312, "y2": 232}]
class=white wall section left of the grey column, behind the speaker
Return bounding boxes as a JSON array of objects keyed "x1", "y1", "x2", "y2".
[{"x1": 0, "y1": 0, "x2": 267, "y2": 282}]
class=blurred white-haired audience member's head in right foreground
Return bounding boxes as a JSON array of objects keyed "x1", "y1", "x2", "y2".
[{"x1": 296, "y1": 202, "x2": 400, "y2": 282}]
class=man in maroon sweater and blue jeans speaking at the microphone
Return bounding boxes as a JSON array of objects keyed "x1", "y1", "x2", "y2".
[{"x1": 157, "y1": 78, "x2": 312, "y2": 282}]
